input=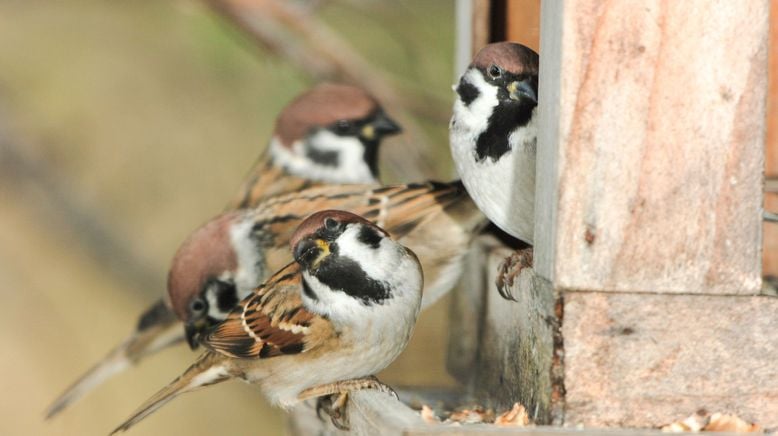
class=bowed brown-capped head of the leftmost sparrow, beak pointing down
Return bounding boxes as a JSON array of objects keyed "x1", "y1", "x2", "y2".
[{"x1": 168, "y1": 211, "x2": 261, "y2": 348}]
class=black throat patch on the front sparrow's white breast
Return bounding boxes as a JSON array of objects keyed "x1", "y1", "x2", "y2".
[{"x1": 314, "y1": 255, "x2": 391, "y2": 306}]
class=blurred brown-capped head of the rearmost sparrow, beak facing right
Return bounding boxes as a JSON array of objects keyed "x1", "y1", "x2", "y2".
[{"x1": 270, "y1": 83, "x2": 401, "y2": 183}]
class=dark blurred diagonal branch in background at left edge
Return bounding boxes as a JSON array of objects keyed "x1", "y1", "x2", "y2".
[{"x1": 0, "y1": 101, "x2": 165, "y2": 295}]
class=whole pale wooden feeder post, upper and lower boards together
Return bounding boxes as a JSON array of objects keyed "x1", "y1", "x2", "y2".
[{"x1": 535, "y1": 0, "x2": 778, "y2": 428}]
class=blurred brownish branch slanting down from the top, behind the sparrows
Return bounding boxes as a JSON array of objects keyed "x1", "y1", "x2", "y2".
[{"x1": 206, "y1": 0, "x2": 448, "y2": 179}]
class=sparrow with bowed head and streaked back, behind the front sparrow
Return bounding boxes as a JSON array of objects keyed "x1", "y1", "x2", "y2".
[{"x1": 168, "y1": 183, "x2": 486, "y2": 347}]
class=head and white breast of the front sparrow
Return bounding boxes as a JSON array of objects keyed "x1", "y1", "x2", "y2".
[{"x1": 290, "y1": 210, "x2": 422, "y2": 321}]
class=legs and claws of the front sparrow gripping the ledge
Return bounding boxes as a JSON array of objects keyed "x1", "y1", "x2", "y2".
[{"x1": 297, "y1": 376, "x2": 397, "y2": 430}]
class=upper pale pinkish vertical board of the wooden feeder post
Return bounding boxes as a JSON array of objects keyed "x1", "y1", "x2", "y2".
[{"x1": 535, "y1": 0, "x2": 769, "y2": 294}]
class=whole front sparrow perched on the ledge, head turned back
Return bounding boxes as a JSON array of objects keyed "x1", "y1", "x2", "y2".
[{"x1": 109, "y1": 210, "x2": 422, "y2": 433}]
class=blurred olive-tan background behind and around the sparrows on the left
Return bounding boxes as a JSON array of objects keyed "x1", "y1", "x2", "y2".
[{"x1": 0, "y1": 0, "x2": 454, "y2": 435}]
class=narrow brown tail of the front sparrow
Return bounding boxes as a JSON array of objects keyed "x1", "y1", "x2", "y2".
[{"x1": 111, "y1": 352, "x2": 230, "y2": 435}]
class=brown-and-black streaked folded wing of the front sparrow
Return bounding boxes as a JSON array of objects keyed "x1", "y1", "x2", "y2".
[{"x1": 202, "y1": 263, "x2": 333, "y2": 359}]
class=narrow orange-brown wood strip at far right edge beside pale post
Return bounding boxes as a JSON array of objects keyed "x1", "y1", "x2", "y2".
[{"x1": 762, "y1": 0, "x2": 778, "y2": 276}]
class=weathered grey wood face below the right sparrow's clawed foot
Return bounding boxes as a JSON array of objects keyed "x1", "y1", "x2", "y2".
[{"x1": 448, "y1": 236, "x2": 561, "y2": 424}]
